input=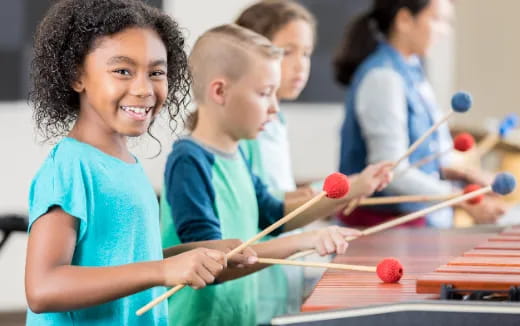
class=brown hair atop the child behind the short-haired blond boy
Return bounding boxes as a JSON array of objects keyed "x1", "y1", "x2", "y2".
[{"x1": 235, "y1": 0, "x2": 316, "y2": 40}]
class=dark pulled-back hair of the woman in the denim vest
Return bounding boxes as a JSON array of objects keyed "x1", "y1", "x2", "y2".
[{"x1": 334, "y1": 0, "x2": 430, "y2": 85}]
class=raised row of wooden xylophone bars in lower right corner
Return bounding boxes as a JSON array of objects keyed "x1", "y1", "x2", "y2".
[{"x1": 417, "y1": 227, "x2": 520, "y2": 300}]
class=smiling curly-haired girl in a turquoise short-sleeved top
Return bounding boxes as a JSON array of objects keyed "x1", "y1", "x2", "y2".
[{"x1": 25, "y1": 0, "x2": 254, "y2": 326}]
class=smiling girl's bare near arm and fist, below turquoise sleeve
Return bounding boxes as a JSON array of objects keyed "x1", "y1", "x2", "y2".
[{"x1": 25, "y1": 207, "x2": 226, "y2": 313}]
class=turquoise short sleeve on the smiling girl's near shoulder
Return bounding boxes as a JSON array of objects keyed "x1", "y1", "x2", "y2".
[{"x1": 28, "y1": 155, "x2": 92, "y2": 242}]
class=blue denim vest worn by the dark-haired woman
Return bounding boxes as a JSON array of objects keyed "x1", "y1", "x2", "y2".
[{"x1": 339, "y1": 42, "x2": 440, "y2": 218}]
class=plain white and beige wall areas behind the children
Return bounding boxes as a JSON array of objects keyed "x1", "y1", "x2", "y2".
[{"x1": 0, "y1": 0, "x2": 520, "y2": 310}]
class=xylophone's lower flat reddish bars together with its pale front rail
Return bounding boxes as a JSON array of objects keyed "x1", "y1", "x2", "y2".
[{"x1": 282, "y1": 226, "x2": 520, "y2": 326}]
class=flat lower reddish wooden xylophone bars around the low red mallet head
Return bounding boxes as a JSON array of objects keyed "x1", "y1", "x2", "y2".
[{"x1": 301, "y1": 228, "x2": 500, "y2": 312}]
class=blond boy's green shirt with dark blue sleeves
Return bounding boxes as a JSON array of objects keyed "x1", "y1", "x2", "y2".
[{"x1": 161, "y1": 138, "x2": 283, "y2": 326}]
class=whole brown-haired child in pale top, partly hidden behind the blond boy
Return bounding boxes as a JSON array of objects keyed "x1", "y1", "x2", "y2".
[{"x1": 236, "y1": 0, "x2": 394, "y2": 324}]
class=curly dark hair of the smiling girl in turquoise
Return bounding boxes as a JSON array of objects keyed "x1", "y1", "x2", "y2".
[{"x1": 29, "y1": 0, "x2": 191, "y2": 140}]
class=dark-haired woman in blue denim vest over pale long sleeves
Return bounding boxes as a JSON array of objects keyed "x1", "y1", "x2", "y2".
[{"x1": 334, "y1": 0, "x2": 504, "y2": 227}]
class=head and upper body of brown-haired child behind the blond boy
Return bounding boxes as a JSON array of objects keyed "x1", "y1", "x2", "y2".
[{"x1": 236, "y1": 0, "x2": 316, "y2": 200}]
